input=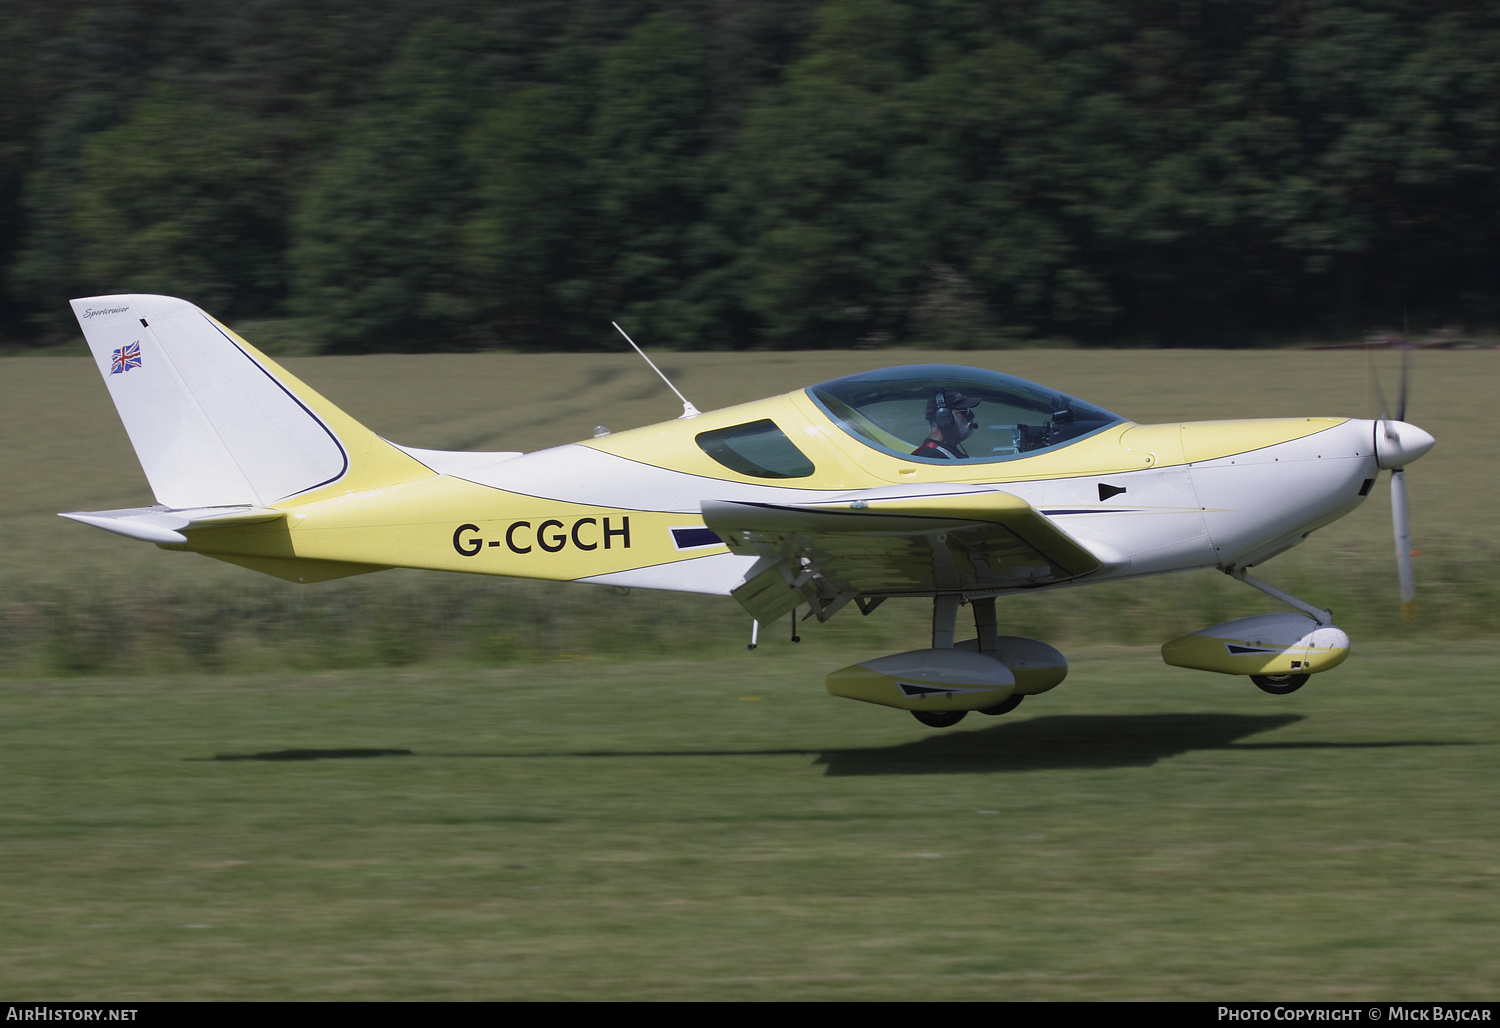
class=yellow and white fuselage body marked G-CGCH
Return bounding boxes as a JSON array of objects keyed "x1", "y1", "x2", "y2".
[{"x1": 182, "y1": 370, "x2": 1377, "y2": 594}]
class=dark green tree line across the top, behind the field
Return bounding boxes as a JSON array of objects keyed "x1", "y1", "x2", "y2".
[{"x1": 0, "y1": 0, "x2": 1500, "y2": 353}]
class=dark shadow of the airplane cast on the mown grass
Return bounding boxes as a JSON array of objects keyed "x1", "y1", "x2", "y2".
[{"x1": 202, "y1": 714, "x2": 1463, "y2": 776}]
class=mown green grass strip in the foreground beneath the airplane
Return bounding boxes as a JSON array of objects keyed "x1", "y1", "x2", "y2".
[{"x1": 0, "y1": 636, "x2": 1500, "y2": 1001}]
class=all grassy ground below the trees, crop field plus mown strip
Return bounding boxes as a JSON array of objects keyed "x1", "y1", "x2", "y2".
[{"x1": 0, "y1": 350, "x2": 1500, "y2": 999}]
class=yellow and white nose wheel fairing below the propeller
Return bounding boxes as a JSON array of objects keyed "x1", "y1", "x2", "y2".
[{"x1": 1161, "y1": 614, "x2": 1349, "y2": 675}]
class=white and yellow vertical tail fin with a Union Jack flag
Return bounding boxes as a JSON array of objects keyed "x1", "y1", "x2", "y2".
[{"x1": 72, "y1": 294, "x2": 432, "y2": 509}]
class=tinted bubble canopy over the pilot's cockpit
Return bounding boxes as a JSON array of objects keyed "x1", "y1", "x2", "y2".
[{"x1": 807, "y1": 365, "x2": 1125, "y2": 464}]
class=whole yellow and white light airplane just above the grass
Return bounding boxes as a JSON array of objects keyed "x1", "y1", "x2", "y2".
[{"x1": 63, "y1": 296, "x2": 1433, "y2": 726}]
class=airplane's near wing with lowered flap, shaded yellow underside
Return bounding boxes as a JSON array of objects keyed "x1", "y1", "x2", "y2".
[{"x1": 702, "y1": 489, "x2": 1106, "y2": 621}]
